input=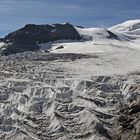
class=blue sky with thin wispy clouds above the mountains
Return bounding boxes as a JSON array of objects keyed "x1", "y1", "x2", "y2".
[{"x1": 0, "y1": 0, "x2": 140, "y2": 37}]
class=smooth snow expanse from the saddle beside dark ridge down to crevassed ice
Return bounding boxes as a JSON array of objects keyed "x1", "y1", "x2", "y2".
[{"x1": 40, "y1": 20, "x2": 140, "y2": 75}]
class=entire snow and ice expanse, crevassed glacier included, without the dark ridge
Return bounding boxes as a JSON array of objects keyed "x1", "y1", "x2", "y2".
[{"x1": 0, "y1": 20, "x2": 140, "y2": 140}]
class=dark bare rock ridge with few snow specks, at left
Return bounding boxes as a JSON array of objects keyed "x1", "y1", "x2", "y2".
[{"x1": 2, "y1": 23, "x2": 81, "y2": 55}]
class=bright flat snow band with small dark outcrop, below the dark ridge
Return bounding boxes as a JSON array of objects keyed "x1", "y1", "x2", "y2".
[{"x1": 50, "y1": 39, "x2": 129, "y2": 54}]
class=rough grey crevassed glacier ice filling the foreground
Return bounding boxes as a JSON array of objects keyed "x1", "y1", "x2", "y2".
[{"x1": 0, "y1": 52, "x2": 140, "y2": 140}]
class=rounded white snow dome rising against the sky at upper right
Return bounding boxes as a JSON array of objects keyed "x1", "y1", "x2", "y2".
[{"x1": 109, "y1": 19, "x2": 140, "y2": 35}]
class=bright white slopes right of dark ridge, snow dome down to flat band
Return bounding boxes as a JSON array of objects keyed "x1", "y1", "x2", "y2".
[{"x1": 47, "y1": 20, "x2": 140, "y2": 54}]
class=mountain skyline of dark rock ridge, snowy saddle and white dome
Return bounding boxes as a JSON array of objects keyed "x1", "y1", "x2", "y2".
[{"x1": 0, "y1": 20, "x2": 140, "y2": 55}]
